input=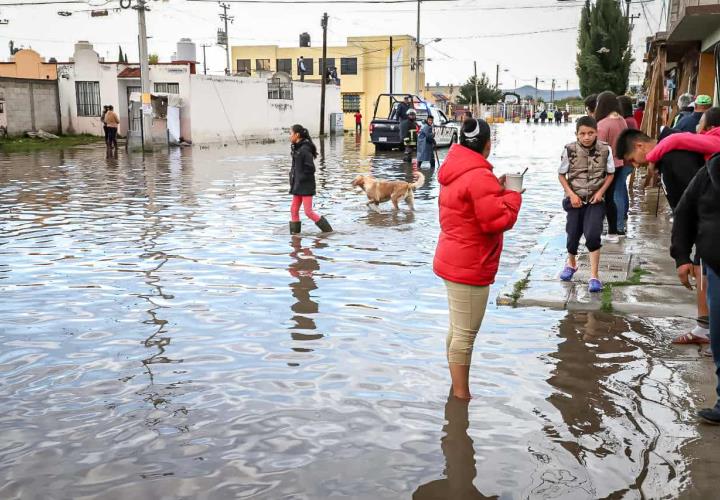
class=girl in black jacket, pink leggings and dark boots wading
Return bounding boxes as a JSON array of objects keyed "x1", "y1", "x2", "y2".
[{"x1": 290, "y1": 125, "x2": 332, "y2": 234}]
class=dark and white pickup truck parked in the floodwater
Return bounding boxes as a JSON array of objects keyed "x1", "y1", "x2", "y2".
[{"x1": 370, "y1": 94, "x2": 462, "y2": 150}]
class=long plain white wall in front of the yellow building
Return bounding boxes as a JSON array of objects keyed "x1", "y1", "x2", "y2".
[{"x1": 190, "y1": 75, "x2": 341, "y2": 143}]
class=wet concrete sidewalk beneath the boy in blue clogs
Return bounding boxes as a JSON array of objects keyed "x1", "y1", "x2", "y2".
[{"x1": 497, "y1": 189, "x2": 697, "y2": 318}]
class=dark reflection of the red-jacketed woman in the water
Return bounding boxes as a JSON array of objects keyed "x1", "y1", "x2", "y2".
[{"x1": 413, "y1": 392, "x2": 499, "y2": 500}]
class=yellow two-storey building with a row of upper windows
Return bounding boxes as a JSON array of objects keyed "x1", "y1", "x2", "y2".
[{"x1": 232, "y1": 35, "x2": 425, "y2": 131}]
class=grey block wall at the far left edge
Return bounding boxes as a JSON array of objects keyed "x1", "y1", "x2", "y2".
[{"x1": 0, "y1": 78, "x2": 60, "y2": 135}]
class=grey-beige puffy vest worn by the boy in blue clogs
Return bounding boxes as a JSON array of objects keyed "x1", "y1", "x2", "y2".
[{"x1": 565, "y1": 141, "x2": 610, "y2": 201}]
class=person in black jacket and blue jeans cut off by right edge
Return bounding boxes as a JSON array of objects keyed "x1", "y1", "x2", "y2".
[{"x1": 670, "y1": 154, "x2": 720, "y2": 425}]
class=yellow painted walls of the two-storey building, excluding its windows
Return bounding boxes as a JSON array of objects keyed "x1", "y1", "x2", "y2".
[{"x1": 232, "y1": 35, "x2": 425, "y2": 133}]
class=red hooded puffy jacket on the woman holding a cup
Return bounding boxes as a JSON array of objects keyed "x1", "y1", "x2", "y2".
[{"x1": 433, "y1": 144, "x2": 522, "y2": 286}]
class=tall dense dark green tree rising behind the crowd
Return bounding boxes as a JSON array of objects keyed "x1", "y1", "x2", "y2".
[{"x1": 576, "y1": 0, "x2": 633, "y2": 96}]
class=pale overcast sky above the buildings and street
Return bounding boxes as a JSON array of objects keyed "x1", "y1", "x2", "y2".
[{"x1": 0, "y1": 0, "x2": 665, "y2": 90}]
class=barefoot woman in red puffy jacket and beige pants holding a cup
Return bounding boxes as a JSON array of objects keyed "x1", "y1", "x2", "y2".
[{"x1": 433, "y1": 118, "x2": 522, "y2": 399}]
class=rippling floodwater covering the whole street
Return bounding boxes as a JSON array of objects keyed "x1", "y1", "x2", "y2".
[{"x1": 0, "y1": 124, "x2": 708, "y2": 500}]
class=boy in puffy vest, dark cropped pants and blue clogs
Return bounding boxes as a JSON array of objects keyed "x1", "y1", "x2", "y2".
[{"x1": 558, "y1": 116, "x2": 615, "y2": 293}]
